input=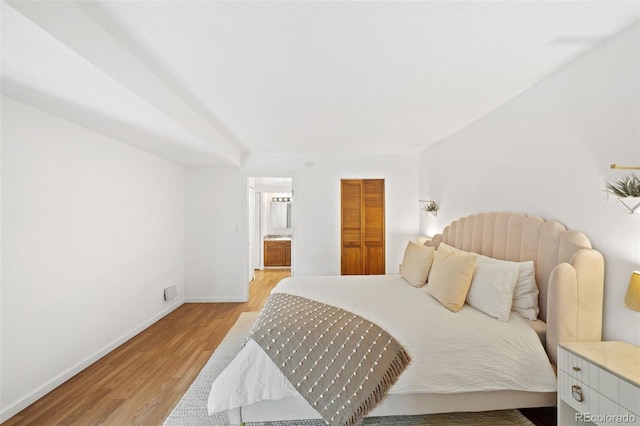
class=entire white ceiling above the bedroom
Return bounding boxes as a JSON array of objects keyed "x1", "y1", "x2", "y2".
[{"x1": 1, "y1": 1, "x2": 640, "y2": 165}]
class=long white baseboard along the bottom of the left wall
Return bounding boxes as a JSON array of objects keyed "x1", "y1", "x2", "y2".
[{"x1": 0, "y1": 299, "x2": 184, "y2": 423}]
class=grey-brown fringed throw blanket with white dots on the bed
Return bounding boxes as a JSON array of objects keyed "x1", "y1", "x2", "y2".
[{"x1": 249, "y1": 293, "x2": 410, "y2": 426}]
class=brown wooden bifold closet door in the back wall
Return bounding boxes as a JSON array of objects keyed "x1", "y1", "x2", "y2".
[{"x1": 341, "y1": 179, "x2": 385, "y2": 275}]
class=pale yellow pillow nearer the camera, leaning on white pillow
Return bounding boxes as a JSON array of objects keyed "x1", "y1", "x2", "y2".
[{"x1": 427, "y1": 250, "x2": 475, "y2": 312}]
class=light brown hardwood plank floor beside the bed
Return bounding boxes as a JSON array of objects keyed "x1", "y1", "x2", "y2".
[{"x1": 3, "y1": 269, "x2": 556, "y2": 426}]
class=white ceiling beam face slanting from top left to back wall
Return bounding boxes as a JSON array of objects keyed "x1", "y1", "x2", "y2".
[{"x1": 9, "y1": 1, "x2": 242, "y2": 166}]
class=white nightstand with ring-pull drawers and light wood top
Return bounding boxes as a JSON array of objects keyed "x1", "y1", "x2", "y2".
[{"x1": 558, "y1": 342, "x2": 640, "y2": 426}]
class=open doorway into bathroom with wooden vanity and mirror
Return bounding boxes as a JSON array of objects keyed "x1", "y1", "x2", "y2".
[{"x1": 247, "y1": 176, "x2": 295, "y2": 282}]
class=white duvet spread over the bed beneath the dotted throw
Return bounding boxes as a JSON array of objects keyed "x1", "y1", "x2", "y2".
[{"x1": 208, "y1": 275, "x2": 556, "y2": 414}]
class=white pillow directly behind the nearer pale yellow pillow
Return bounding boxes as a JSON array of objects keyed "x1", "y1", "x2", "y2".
[{"x1": 467, "y1": 256, "x2": 520, "y2": 321}]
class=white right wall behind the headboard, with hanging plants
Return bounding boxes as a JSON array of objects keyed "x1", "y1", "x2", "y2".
[{"x1": 420, "y1": 24, "x2": 640, "y2": 344}]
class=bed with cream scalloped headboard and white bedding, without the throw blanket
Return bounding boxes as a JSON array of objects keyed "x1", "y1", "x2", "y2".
[{"x1": 209, "y1": 213, "x2": 604, "y2": 424}]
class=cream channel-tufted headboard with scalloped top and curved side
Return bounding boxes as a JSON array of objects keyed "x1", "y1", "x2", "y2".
[{"x1": 425, "y1": 213, "x2": 604, "y2": 363}]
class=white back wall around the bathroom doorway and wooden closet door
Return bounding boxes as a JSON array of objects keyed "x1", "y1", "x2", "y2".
[{"x1": 186, "y1": 154, "x2": 420, "y2": 301}]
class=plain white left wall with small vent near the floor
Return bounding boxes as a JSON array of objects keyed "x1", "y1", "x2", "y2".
[{"x1": 1, "y1": 97, "x2": 184, "y2": 419}]
